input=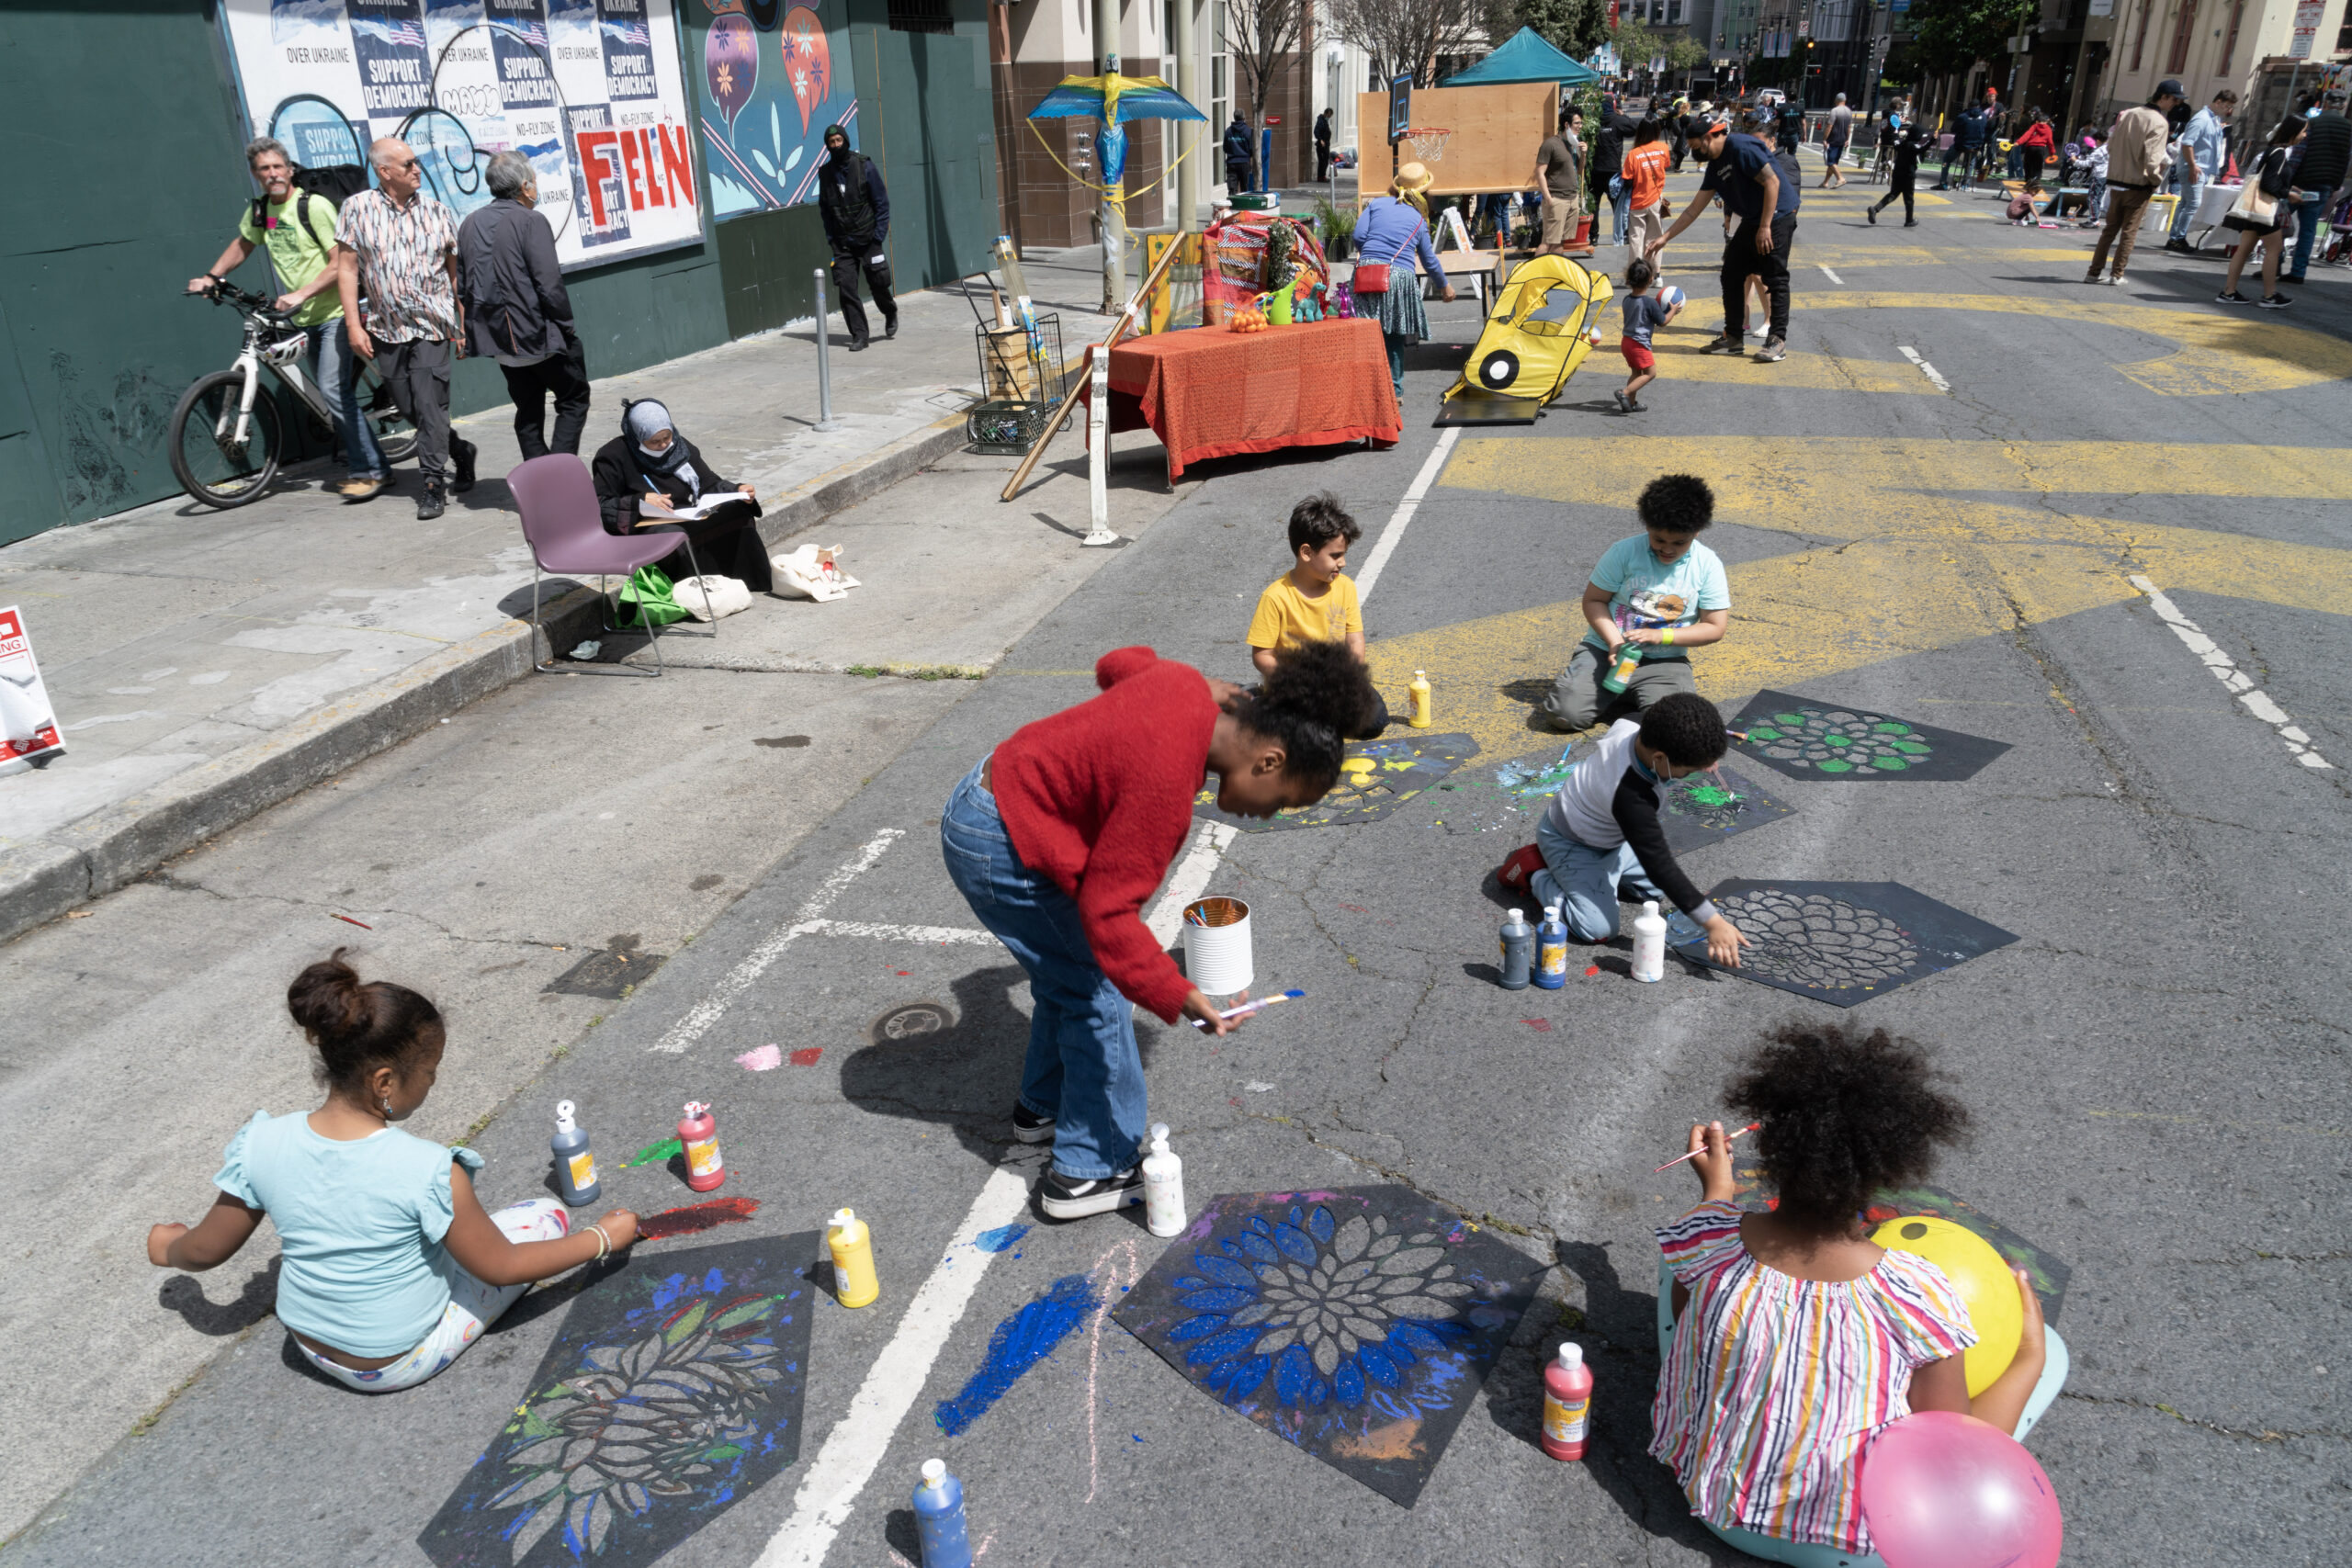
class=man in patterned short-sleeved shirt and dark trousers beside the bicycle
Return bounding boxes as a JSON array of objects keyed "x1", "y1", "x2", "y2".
[{"x1": 334, "y1": 136, "x2": 475, "y2": 520}]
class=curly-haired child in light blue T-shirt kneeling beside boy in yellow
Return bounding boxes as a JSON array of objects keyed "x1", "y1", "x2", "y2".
[{"x1": 1543, "y1": 472, "x2": 1731, "y2": 728}]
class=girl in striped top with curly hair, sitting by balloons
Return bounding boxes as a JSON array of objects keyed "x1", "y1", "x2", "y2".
[{"x1": 1649, "y1": 1022, "x2": 2055, "y2": 1568}]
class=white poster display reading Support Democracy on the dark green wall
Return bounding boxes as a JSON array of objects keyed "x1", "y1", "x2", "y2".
[{"x1": 223, "y1": 0, "x2": 695, "y2": 270}]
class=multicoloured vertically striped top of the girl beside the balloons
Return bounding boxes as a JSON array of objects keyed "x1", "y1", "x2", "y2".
[{"x1": 1649, "y1": 1203, "x2": 1975, "y2": 1551}]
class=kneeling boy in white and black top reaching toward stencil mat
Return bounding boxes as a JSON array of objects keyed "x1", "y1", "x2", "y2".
[{"x1": 1496, "y1": 691, "x2": 1747, "y2": 966}]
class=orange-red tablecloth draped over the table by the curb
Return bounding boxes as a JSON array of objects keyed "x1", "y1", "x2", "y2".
[{"x1": 1080, "y1": 320, "x2": 1404, "y2": 484}]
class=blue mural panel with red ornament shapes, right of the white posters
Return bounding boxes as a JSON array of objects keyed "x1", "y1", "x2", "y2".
[{"x1": 682, "y1": 0, "x2": 858, "y2": 219}]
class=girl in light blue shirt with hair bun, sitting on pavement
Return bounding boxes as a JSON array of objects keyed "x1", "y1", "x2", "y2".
[{"x1": 148, "y1": 947, "x2": 638, "y2": 1394}]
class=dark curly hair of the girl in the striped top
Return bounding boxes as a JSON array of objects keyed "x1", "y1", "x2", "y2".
[{"x1": 1724, "y1": 1022, "x2": 1969, "y2": 1235}]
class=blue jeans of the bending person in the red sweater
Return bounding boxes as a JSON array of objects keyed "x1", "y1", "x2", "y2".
[{"x1": 938, "y1": 760, "x2": 1146, "y2": 1180}]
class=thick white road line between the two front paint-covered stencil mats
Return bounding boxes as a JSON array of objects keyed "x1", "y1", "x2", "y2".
[{"x1": 752, "y1": 1166, "x2": 1028, "y2": 1568}]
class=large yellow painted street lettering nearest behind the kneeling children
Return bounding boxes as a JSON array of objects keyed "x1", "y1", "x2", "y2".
[{"x1": 1371, "y1": 437, "x2": 2352, "y2": 757}]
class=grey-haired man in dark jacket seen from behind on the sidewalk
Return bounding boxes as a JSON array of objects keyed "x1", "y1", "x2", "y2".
[{"x1": 457, "y1": 151, "x2": 588, "y2": 458}]
